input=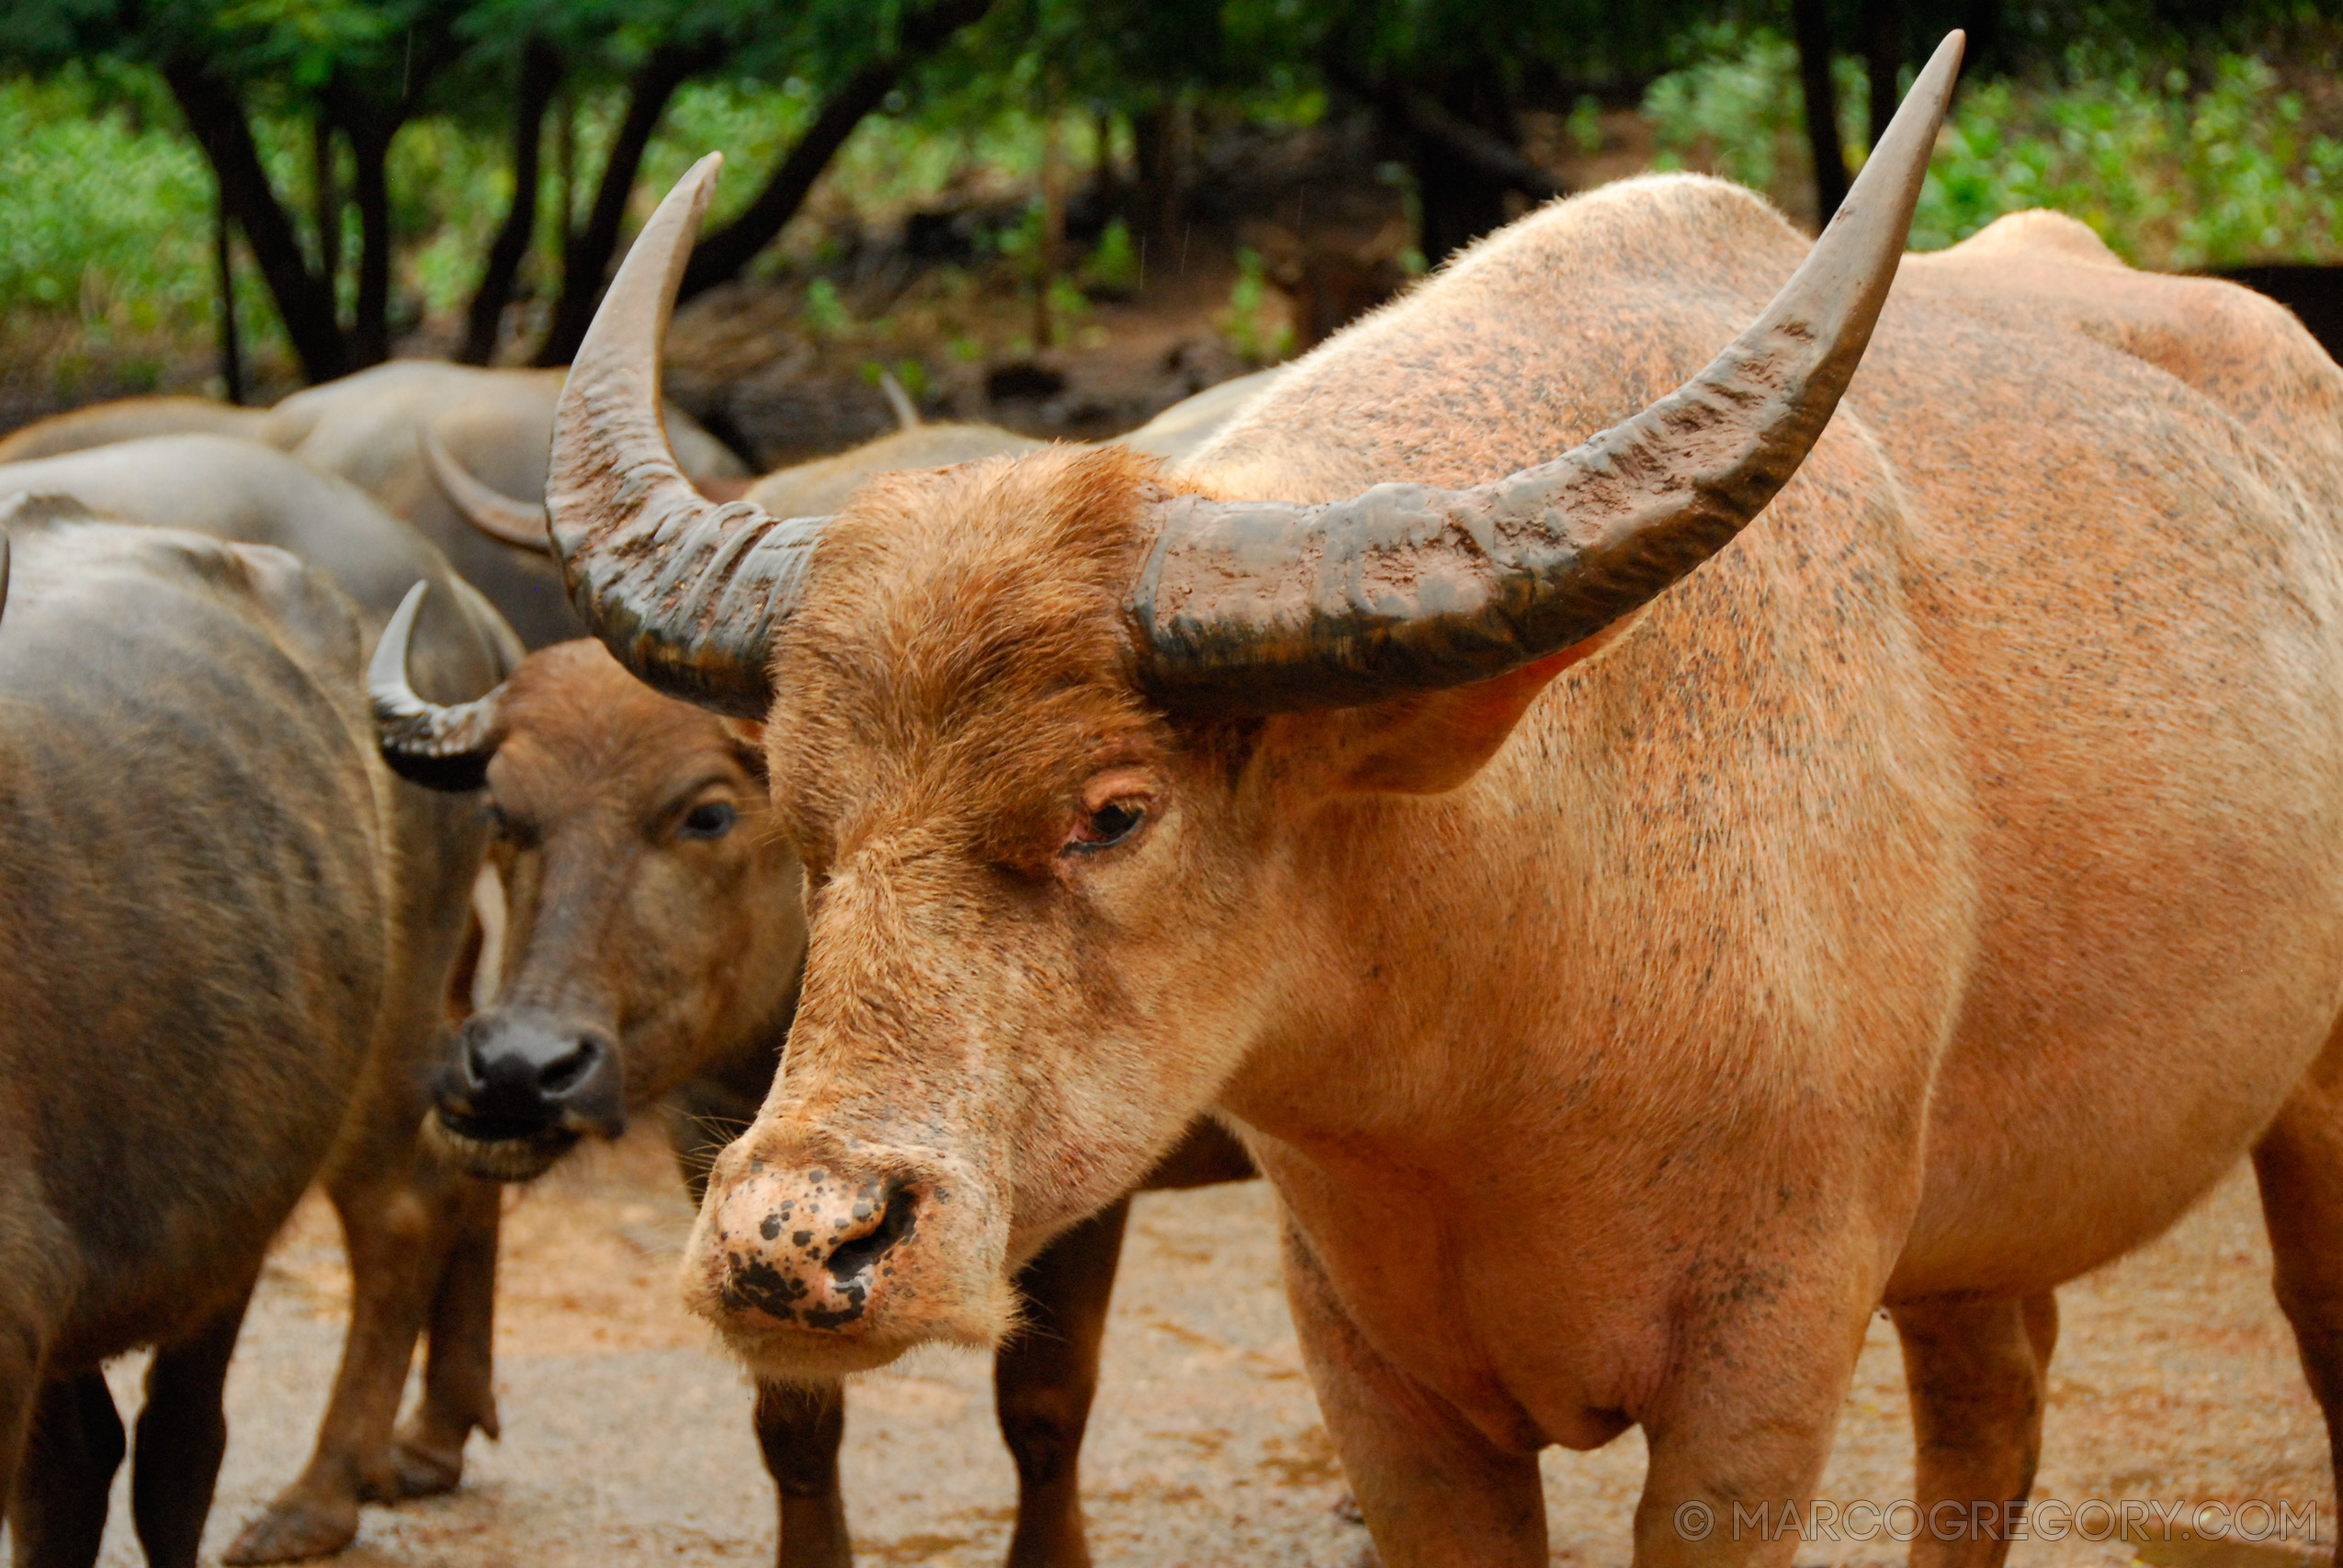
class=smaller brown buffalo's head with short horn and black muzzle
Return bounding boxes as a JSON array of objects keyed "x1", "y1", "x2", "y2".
[{"x1": 370, "y1": 585, "x2": 806, "y2": 1181}]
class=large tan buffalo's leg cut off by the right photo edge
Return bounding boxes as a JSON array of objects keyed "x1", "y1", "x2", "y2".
[{"x1": 2254, "y1": 1029, "x2": 2343, "y2": 1476}]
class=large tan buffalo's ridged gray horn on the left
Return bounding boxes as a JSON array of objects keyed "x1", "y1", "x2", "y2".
[{"x1": 546, "y1": 152, "x2": 825, "y2": 719}]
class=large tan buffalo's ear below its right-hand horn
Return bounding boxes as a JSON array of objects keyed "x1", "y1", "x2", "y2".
[{"x1": 1321, "y1": 612, "x2": 1643, "y2": 795}]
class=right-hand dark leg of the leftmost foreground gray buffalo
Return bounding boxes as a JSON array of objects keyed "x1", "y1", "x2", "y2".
[{"x1": 131, "y1": 1292, "x2": 251, "y2": 1568}]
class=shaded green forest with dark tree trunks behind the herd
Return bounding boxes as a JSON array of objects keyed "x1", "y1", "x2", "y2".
[{"x1": 0, "y1": 0, "x2": 2343, "y2": 464}]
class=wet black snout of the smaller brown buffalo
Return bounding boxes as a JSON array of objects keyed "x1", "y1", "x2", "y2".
[{"x1": 434, "y1": 1010, "x2": 626, "y2": 1181}]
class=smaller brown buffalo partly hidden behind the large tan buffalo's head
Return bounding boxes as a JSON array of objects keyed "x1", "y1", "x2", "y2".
[{"x1": 372, "y1": 592, "x2": 1253, "y2": 1568}]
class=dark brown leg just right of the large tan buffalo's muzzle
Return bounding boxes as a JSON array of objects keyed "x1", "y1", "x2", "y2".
[{"x1": 993, "y1": 1198, "x2": 1132, "y2": 1568}]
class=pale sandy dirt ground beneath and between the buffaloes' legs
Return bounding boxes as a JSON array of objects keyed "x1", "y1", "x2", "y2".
[{"x1": 63, "y1": 1139, "x2": 2334, "y2": 1568}]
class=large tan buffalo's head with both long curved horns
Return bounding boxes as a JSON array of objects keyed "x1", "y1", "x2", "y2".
[{"x1": 549, "y1": 42, "x2": 1959, "y2": 1378}]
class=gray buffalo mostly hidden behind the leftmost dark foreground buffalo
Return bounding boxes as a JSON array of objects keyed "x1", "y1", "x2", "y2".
[{"x1": 0, "y1": 436, "x2": 523, "y2": 1561}]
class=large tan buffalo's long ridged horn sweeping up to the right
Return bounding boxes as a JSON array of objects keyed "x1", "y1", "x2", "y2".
[{"x1": 1129, "y1": 33, "x2": 1961, "y2": 715}]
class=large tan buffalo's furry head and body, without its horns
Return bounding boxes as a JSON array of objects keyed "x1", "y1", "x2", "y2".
[{"x1": 686, "y1": 175, "x2": 2343, "y2": 1568}]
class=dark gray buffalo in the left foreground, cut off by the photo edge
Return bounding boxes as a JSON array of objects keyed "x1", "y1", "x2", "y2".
[{"x1": 0, "y1": 497, "x2": 470, "y2": 1568}]
